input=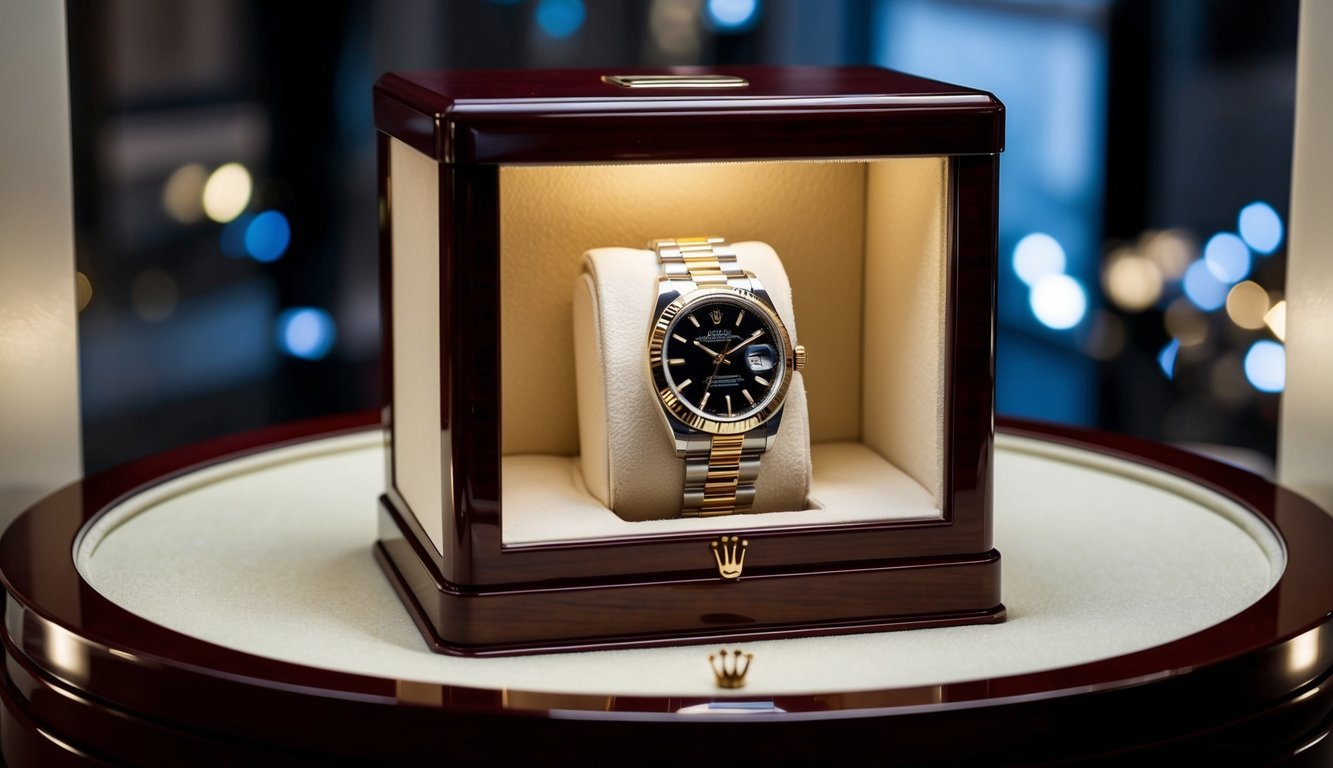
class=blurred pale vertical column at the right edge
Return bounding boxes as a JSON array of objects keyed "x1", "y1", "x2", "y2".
[{"x1": 1277, "y1": 3, "x2": 1333, "y2": 511}]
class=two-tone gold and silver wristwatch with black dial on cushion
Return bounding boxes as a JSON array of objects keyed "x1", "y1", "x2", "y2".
[{"x1": 648, "y1": 237, "x2": 805, "y2": 517}]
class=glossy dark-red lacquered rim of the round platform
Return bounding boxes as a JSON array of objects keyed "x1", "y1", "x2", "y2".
[{"x1": 0, "y1": 415, "x2": 1333, "y2": 765}]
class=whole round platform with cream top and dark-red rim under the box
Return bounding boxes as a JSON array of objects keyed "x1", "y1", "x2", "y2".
[{"x1": 0, "y1": 417, "x2": 1333, "y2": 765}]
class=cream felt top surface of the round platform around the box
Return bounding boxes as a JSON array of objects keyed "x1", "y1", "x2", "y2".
[{"x1": 75, "y1": 432, "x2": 1284, "y2": 697}]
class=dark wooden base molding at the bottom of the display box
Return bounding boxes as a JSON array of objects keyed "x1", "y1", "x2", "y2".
[{"x1": 375, "y1": 496, "x2": 1005, "y2": 656}]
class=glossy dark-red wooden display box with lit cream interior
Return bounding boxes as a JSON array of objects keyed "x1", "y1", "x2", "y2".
[{"x1": 375, "y1": 67, "x2": 1004, "y2": 655}]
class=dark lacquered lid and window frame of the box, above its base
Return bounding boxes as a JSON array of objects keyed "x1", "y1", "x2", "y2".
[{"x1": 376, "y1": 67, "x2": 1004, "y2": 594}]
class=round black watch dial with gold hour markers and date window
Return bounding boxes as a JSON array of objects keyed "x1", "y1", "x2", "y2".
[{"x1": 663, "y1": 300, "x2": 785, "y2": 421}]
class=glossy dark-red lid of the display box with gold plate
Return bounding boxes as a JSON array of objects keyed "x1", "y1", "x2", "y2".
[{"x1": 375, "y1": 67, "x2": 1004, "y2": 164}]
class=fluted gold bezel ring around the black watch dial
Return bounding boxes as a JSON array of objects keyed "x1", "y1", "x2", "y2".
[{"x1": 648, "y1": 285, "x2": 794, "y2": 435}]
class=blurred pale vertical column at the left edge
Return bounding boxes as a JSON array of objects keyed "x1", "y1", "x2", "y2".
[{"x1": 0, "y1": 3, "x2": 81, "y2": 528}]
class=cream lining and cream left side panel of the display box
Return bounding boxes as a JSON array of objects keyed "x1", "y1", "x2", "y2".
[{"x1": 391, "y1": 141, "x2": 949, "y2": 547}]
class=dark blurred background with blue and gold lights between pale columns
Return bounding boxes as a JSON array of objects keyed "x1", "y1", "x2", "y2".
[{"x1": 68, "y1": 0, "x2": 1297, "y2": 472}]
